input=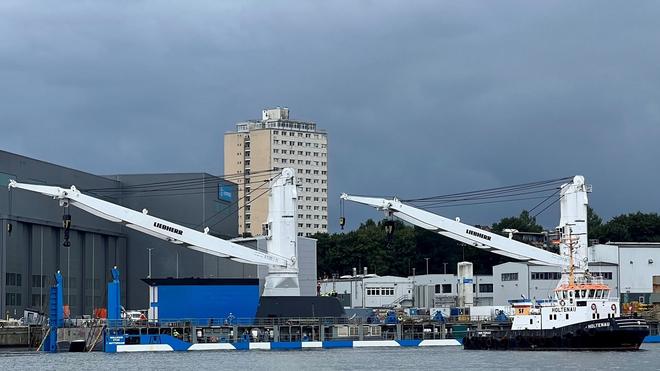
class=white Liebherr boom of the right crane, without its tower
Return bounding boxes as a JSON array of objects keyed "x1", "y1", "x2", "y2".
[{"x1": 341, "y1": 193, "x2": 563, "y2": 266}]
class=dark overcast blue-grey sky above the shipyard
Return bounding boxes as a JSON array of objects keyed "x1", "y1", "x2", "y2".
[{"x1": 0, "y1": 0, "x2": 660, "y2": 230}]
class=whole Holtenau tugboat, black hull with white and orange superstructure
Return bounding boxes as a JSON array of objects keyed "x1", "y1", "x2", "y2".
[{"x1": 463, "y1": 230, "x2": 649, "y2": 350}]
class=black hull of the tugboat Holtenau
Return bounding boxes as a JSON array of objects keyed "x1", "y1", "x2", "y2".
[{"x1": 463, "y1": 317, "x2": 649, "y2": 350}]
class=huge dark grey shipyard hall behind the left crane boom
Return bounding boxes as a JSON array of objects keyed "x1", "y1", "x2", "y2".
[{"x1": 0, "y1": 151, "x2": 316, "y2": 318}]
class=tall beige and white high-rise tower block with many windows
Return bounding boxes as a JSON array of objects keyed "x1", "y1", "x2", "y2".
[{"x1": 224, "y1": 107, "x2": 328, "y2": 236}]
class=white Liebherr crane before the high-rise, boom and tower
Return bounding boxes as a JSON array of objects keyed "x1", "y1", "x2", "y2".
[{"x1": 9, "y1": 168, "x2": 300, "y2": 296}]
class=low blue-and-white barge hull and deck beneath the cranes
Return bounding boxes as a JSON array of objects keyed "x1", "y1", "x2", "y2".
[{"x1": 104, "y1": 318, "x2": 461, "y2": 353}]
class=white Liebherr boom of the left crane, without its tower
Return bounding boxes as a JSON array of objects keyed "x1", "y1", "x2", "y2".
[{"x1": 9, "y1": 180, "x2": 296, "y2": 267}]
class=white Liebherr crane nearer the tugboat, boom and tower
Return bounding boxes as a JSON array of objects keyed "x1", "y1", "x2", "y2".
[{"x1": 341, "y1": 176, "x2": 588, "y2": 270}]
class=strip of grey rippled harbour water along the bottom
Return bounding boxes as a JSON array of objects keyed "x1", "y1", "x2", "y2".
[{"x1": 0, "y1": 344, "x2": 660, "y2": 371}]
